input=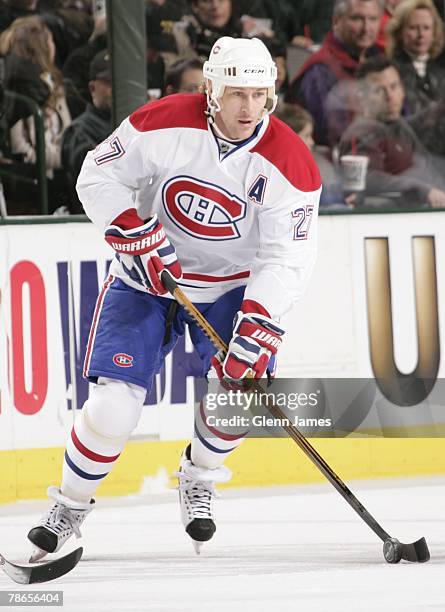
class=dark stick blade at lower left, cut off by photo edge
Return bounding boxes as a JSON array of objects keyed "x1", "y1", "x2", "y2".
[{"x1": 0, "y1": 547, "x2": 83, "y2": 584}]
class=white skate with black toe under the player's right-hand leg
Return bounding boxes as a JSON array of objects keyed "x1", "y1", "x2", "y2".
[{"x1": 176, "y1": 446, "x2": 232, "y2": 555}]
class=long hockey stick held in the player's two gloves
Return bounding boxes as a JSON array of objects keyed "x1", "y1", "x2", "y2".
[{"x1": 161, "y1": 270, "x2": 430, "y2": 563}]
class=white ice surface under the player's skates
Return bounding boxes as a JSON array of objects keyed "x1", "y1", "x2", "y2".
[{"x1": 0, "y1": 478, "x2": 445, "y2": 612}]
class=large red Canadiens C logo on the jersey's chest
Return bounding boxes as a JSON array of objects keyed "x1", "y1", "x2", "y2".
[{"x1": 162, "y1": 176, "x2": 247, "y2": 240}]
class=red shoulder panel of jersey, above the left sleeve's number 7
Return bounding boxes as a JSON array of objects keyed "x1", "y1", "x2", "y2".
[{"x1": 130, "y1": 94, "x2": 207, "y2": 132}]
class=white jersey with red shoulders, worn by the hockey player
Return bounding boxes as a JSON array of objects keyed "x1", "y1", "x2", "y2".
[{"x1": 77, "y1": 94, "x2": 321, "y2": 319}]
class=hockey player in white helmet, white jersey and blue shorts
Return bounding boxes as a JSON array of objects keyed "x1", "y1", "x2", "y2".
[{"x1": 28, "y1": 37, "x2": 320, "y2": 560}]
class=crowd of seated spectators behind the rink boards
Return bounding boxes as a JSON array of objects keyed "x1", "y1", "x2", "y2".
[{"x1": 0, "y1": 0, "x2": 445, "y2": 214}]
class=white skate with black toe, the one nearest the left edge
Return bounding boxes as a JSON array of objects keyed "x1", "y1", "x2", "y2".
[{"x1": 28, "y1": 487, "x2": 94, "y2": 563}]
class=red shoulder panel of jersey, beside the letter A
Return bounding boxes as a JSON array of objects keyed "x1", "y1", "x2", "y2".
[{"x1": 250, "y1": 116, "x2": 321, "y2": 192}]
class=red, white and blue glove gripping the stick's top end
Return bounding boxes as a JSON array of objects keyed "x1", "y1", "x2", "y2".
[{"x1": 105, "y1": 211, "x2": 182, "y2": 295}]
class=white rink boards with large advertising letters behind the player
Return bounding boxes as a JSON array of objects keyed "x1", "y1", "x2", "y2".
[{"x1": 0, "y1": 212, "x2": 445, "y2": 450}]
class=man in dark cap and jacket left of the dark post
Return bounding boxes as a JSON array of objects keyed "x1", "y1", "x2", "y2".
[{"x1": 62, "y1": 51, "x2": 112, "y2": 213}]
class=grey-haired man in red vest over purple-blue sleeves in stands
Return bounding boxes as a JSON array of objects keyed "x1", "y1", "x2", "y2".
[{"x1": 287, "y1": 0, "x2": 382, "y2": 145}]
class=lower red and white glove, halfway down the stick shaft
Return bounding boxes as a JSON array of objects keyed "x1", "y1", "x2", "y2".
[{"x1": 211, "y1": 304, "x2": 284, "y2": 380}]
